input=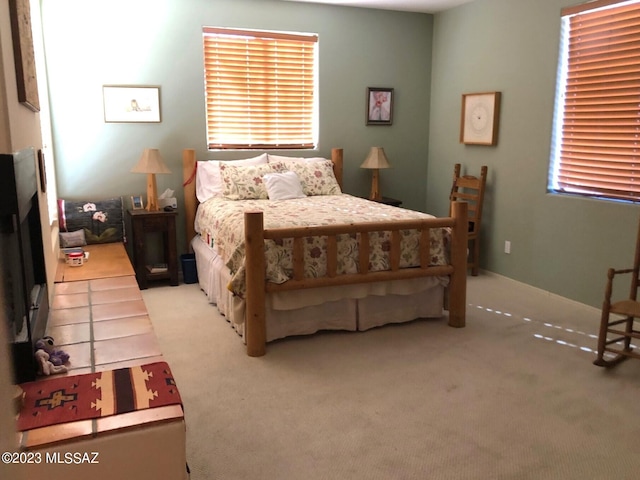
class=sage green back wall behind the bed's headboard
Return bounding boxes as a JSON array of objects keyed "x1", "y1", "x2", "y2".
[{"x1": 42, "y1": 0, "x2": 433, "y2": 253}]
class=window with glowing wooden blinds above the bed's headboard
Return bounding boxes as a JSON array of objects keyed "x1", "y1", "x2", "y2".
[{"x1": 203, "y1": 27, "x2": 318, "y2": 150}]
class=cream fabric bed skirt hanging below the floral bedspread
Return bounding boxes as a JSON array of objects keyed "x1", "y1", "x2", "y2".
[{"x1": 191, "y1": 236, "x2": 448, "y2": 342}]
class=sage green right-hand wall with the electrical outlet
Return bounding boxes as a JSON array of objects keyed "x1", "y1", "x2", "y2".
[{"x1": 426, "y1": 0, "x2": 639, "y2": 306}]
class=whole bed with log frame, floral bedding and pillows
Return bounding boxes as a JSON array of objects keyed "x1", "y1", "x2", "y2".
[{"x1": 183, "y1": 148, "x2": 468, "y2": 356}]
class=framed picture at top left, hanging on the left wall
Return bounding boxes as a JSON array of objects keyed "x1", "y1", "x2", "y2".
[{"x1": 9, "y1": 0, "x2": 40, "y2": 112}]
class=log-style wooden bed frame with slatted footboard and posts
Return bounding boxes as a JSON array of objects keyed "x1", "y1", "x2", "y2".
[{"x1": 182, "y1": 148, "x2": 468, "y2": 357}]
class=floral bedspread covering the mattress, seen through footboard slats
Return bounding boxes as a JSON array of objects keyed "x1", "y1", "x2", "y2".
[{"x1": 195, "y1": 194, "x2": 449, "y2": 296}]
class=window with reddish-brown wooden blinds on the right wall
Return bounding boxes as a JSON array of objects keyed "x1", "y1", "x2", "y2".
[{"x1": 549, "y1": 0, "x2": 640, "y2": 202}]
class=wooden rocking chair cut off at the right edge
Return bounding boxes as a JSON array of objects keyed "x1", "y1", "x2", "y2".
[{"x1": 593, "y1": 221, "x2": 640, "y2": 367}]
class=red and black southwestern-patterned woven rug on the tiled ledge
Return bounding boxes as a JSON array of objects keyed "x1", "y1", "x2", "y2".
[{"x1": 18, "y1": 362, "x2": 182, "y2": 431}]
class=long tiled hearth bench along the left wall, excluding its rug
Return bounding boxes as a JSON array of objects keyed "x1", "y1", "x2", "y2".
[{"x1": 12, "y1": 243, "x2": 189, "y2": 480}]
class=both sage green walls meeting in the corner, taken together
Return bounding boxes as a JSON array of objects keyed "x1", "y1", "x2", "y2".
[{"x1": 42, "y1": 0, "x2": 638, "y2": 306}]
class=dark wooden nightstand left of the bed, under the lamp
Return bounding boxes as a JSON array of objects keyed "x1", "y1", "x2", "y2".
[{"x1": 128, "y1": 210, "x2": 178, "y2": 290}]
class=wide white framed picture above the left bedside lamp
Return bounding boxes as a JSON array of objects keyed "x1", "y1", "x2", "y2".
[{"x1": 102, "y1": 85, "x2": 161, "y2": 123}]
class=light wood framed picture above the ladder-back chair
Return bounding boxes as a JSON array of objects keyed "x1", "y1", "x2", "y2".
[{"x1": 460, "y1": 92, "x2": 500, "y2": 145}]
